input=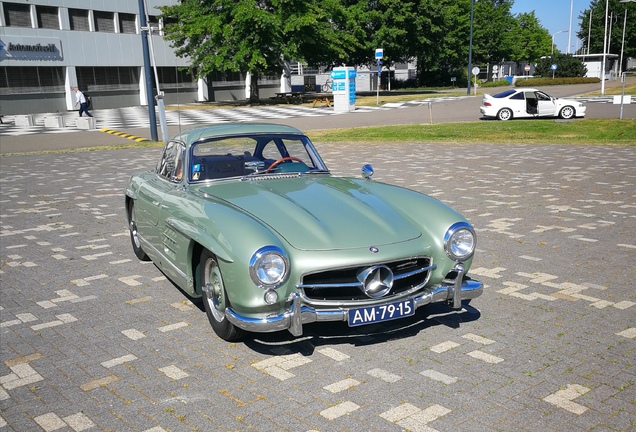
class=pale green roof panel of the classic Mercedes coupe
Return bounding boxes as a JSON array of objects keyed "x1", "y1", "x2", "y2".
[{"x1": 172, "y1": 123, "x2": 304, "y2": 144}]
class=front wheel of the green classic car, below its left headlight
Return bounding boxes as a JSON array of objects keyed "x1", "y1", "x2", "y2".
[{"x1": 197, "y1": 250, "x2": 245, "y2": 342}]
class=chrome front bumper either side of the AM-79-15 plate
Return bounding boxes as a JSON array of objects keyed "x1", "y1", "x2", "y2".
[{"x1": 225, "y1": 265, "x2": 483, "y2": 336}]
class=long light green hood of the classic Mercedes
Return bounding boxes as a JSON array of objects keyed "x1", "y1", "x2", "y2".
[{"x1": 191, "y1": 176, "x2": 421, "y2": 250}]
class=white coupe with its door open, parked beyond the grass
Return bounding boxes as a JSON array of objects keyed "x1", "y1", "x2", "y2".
[{"x1": 479, "y1": 88, "x2": 585, "y2": 120}]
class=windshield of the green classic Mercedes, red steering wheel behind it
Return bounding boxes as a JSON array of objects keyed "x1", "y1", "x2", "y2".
[{"x1": 188, "y1": 134, "x2": 327, "y2": 182}]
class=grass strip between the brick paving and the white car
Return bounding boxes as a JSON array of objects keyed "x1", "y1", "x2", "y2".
[{"x1": 308, "y1": 119, "x2": 636, "y2": 146}]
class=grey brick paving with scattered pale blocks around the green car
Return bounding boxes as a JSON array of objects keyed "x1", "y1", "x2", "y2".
[{"x1": 0, "y1": 144, "x2": 636, "y2": 432}]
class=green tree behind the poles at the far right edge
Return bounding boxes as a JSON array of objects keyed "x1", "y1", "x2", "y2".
[{"x1": 576, "y1": 0, "x2": 636, "y2": 70}]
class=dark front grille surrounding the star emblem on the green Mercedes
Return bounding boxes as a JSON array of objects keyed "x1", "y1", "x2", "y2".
[{"x1": 298, "y1": 257, "x2": 435, "y2": 301}]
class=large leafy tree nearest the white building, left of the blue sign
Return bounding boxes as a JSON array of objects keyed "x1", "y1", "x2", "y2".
[{"x1": 161, "y1": 0, "x2": 363, "y2": 100}]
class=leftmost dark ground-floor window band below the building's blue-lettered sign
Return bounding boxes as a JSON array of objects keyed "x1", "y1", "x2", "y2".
[{"x1": 0, "y1": 66, "x2": 64, "y2": 94}]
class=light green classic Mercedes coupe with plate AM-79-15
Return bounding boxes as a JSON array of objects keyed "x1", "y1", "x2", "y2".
[{"x1": 126, "y1": 123, "x2": 483, "y2": 341}]
